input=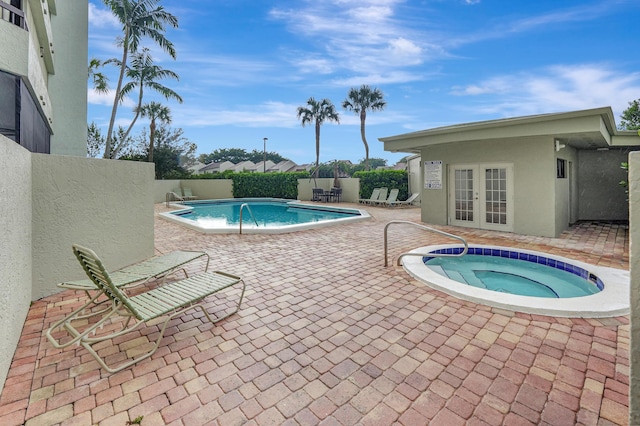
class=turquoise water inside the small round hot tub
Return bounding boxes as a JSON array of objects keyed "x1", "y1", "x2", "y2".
[{"x1": 424, "y1": 249, "x2": 602, "y2": 298}]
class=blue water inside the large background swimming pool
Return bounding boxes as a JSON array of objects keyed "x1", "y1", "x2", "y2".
[{"x1": 171, "y1": 199, "x2": 361, "y2": 228}]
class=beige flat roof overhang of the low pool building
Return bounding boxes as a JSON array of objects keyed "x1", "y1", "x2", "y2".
[{"x1": 379, "y1": 107, "x2": 640, "y2": 152}]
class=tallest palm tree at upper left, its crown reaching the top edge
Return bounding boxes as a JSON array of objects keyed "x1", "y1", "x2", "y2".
[{"x1": 104, "y1": 0, "x2": 178, "y2": 158}]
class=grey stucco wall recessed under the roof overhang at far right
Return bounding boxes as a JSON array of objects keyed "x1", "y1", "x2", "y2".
[{"x1": 578, "y1": 148, "x2": 637, "y2": 221}]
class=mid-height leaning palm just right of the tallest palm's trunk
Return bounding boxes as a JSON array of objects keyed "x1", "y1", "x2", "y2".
[{"x1": 112, "y1": 48, "x2": 182, "y2": 155}]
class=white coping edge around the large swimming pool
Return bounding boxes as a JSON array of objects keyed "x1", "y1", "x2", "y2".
[{"x1": 159, "y1": 198, "x2": 371, "y2": 234}]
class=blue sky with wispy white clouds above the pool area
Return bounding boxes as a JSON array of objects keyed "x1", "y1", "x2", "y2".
[{"x1": 88, "y1": 0, "x2": 640, "y2": 164}]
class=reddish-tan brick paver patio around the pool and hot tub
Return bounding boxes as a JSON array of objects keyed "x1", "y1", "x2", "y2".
[{"x1": 0, "y1": 205, "x2": 629, "y2": 426}]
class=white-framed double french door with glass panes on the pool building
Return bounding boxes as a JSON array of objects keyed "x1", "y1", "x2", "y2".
[{"x1": 448, "y1": 164, "x2": 513, "y2": 231}]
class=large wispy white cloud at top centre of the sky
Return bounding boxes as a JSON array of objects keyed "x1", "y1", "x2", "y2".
[{"x1": 271, "y1": 0, "x2": 440, "y2": 85}]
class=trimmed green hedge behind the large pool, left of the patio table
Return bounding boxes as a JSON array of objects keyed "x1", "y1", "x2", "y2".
[{"x1": 228, "y1": 172, "x2": 309, "y2": 200}]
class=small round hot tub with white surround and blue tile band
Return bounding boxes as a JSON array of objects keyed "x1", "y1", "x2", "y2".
[{"x1": 403, "y1": 244, "x2": 630, "y2": 318}]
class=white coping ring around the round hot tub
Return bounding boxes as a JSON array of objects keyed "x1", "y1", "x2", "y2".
[{"x1": 402, "y1": 244, "x2": 630, "y2": 318}]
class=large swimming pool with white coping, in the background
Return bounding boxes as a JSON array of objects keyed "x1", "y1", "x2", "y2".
[{"x1": 160, "y1": 198, "x2": 370, "y2": 234}]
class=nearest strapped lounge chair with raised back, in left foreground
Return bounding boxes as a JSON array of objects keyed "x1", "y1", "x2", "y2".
[{"x1": 46, "y1": 245, "x2": 246, "y2": 373}]
